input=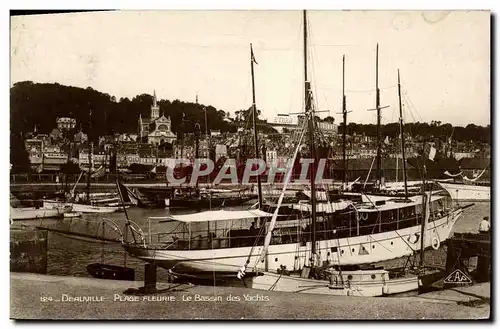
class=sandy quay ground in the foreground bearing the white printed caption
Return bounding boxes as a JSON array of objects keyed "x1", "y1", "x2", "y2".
[{"x1": 10, "y1": 272, "x2": 491, "y2": 320}]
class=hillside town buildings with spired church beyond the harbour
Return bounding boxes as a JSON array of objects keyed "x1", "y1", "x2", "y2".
[{"x1": 20, "y1": 88, "x2": 490, "y2": 179}]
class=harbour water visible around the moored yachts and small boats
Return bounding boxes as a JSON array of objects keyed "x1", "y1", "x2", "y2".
[{"x1": 10, "y1": 202, "x2": 491, "y2": 281}]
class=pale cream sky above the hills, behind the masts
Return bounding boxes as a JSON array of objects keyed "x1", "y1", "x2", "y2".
[{"x1": 10, "y1": 10, "x2": 490, "y2": 126}]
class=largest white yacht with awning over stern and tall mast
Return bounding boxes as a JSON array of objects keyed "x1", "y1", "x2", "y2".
[{"x1": 123, "y1": 12, "x2": 464, "y2": 277}]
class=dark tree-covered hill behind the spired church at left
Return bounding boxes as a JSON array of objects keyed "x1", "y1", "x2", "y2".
[{"x1": 10, "y1": 81, "x2": 236, "y2": 141}]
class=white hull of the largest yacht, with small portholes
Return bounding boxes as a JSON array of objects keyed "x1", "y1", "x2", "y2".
[{"x1": 124, "y1": 208, "x2": 463, "y2": 273}]
